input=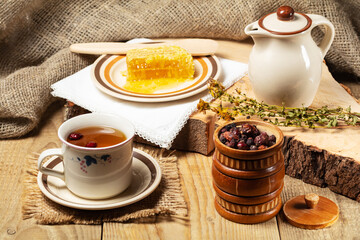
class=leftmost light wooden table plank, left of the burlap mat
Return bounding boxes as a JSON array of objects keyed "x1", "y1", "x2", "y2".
[{"x1": 0, "y1": 104, "x2": 101, "y2": 239}]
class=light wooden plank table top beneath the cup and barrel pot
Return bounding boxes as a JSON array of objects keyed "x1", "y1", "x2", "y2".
[{"x1": 0, "y1": 41, "x2": 360, "y2": 239}]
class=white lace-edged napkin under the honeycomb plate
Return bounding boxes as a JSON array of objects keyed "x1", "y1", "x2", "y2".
[{"x1": 51, "y1": 39, "x2": 248, "y2": 149}]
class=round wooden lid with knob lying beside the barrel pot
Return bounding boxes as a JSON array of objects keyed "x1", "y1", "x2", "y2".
[{"x1": 283, "y1": 193, "x2": 339, "y2": 229}]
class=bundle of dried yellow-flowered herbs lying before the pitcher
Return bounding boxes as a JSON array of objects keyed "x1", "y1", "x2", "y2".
[{"x1": 197, "y1": 80, "x2": 360, "y2": 128}]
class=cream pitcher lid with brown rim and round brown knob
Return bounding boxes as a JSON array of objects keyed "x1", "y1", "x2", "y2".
[{"x1": 259, "y1": 6, "x2": 312, "y2": 35}]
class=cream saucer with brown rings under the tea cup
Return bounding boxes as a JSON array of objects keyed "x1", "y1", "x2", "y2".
[{"x1": 37, "y1": 149, "x2": 161, "y2": 210}]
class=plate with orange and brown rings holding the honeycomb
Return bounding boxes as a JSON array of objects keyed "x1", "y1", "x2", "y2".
[{"x1": 91, "y1": 54, "x2": 221, "y2": 102}]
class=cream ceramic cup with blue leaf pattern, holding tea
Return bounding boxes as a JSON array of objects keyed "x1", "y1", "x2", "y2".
[{"x1": 38, "y1": 113, "x2": 135, "y2": 199}]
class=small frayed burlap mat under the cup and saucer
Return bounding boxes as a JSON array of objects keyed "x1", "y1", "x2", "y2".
[{"x1": 23, "y1": 144, "x2": 188, "y2": 224}]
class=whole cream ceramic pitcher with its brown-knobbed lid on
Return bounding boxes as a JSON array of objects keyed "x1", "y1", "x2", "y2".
[{"x1": 245, "y1": 6, "x2": 335, "y2": 107}]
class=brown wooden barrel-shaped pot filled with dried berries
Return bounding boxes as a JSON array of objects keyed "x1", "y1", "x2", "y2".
[{"x1": 212, "y1": 120, "x2": 285, "y2": 223}]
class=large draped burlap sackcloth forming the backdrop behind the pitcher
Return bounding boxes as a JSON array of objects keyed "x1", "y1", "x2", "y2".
[{"x1": 0, "y1": 0, "x2": 360, "y2": 138}]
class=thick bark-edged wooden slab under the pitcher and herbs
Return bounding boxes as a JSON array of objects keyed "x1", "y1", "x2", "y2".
[{"x1": 65, "y1": 41, "x2": 360, "y2": 202}]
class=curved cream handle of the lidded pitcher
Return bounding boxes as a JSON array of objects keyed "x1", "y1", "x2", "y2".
[{"x1": 308, "y1": 14, "x2": 335, "y2": 58}]
